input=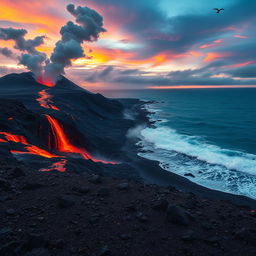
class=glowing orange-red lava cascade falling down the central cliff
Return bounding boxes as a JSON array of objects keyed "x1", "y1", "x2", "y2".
[{"x1": 45, "y1": 115, "x2": 116, "y2": 164}]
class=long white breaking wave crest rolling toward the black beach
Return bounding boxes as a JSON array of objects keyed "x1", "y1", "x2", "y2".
[{"x1": 141, "y1": 127, "x2": 256, "y2": 175}]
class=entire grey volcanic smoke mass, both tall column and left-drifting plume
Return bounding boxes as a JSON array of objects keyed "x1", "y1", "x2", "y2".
[{"x1": 0, "y1": 4, "x2": 106, "y2": 83}]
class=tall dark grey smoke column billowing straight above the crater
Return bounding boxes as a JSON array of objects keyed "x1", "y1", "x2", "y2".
[{"x1": 45, "y1": 4, "x2": 106, "y2": 82}]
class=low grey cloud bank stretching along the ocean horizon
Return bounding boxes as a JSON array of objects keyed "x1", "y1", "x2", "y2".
[{"x1": 77, "y1": 64, "x2": 256, "y2": 88}]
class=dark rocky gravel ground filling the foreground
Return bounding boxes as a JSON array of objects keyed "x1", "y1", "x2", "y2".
[{"x1": 0, "y1": 164, "x2": 256, "y2": 256}]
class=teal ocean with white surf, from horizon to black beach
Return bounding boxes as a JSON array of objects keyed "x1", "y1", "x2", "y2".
[{"x1": 101, "y1": 88, "x2": 256, "y2": 199}]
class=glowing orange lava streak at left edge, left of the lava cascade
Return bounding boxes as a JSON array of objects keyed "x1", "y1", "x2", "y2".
[{"x1": 0, "y1": 132, "x2": 60, "y2": 158}]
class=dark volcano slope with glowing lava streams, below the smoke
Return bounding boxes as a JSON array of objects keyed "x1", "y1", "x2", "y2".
[{"x1": 0, "y1": 72, "x2": 141, "y2": 177}]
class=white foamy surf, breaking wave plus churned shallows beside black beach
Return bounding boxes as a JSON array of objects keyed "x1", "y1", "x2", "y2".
[{"x1": 140, "y1": 126, "x2": 256, "y2": 198}]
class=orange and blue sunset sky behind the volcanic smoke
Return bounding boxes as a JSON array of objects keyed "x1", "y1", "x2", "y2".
[{"x1": 0, "y1": 0, "x2": 256, "y2": 89}]
